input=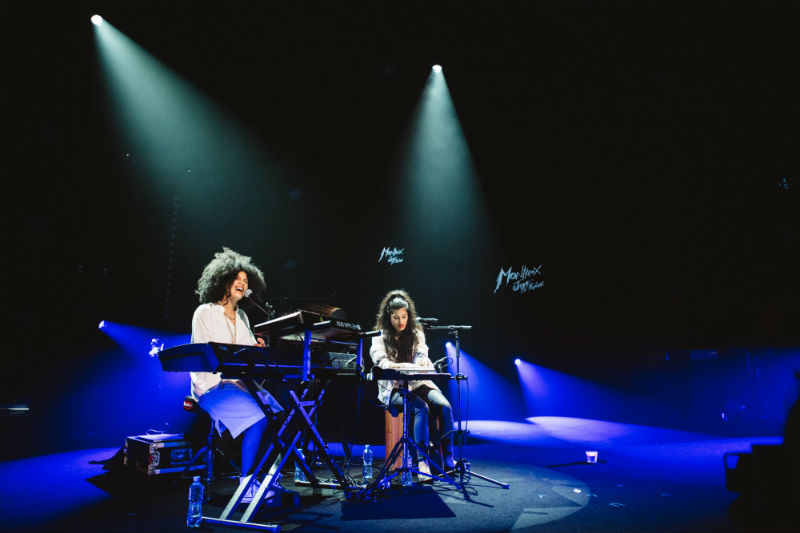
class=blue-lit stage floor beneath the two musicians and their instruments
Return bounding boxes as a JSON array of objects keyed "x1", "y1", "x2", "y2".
[{"x1": 0, "y1": 417, "x2": 782, "y2": 532}]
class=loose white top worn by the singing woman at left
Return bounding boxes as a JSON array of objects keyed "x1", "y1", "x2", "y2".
[{"x1": 190, "y1": 303, "x2": 256, "y2": 399}]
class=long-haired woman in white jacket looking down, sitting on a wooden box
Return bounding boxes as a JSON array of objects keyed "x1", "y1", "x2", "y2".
[{"x1": 369, "y1": 290, "x2": 455, "y2": 473}]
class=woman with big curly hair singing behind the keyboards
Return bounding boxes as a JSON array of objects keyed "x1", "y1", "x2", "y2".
[{"x1": 191, "y1": 248, "x2": 283, "y2": 503}]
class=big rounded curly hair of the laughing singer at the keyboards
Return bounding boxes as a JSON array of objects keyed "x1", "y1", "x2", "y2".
[{"x1": 194, "y1": 246, "x2": 267, "y2": 304}]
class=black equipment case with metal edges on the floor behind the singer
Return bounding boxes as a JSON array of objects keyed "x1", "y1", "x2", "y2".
[{"x1": 124, "y1": 433, "x2": 206, "y2": 476}]
